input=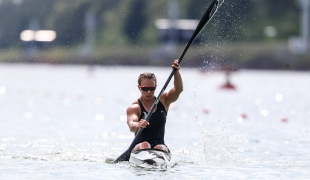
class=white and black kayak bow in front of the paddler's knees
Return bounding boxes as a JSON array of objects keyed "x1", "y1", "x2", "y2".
[{"x1": 129, "y1": 148, "x2": 171, "y2": 170}]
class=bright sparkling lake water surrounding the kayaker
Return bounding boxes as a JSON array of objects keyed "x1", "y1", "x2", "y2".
[{"x1": 0, "y1": 64, "x2": 310, "y2": 179}]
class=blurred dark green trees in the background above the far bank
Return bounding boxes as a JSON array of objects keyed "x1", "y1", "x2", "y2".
[{"x1": 0, "y1": 0, "x2": 300, "y2": 49}]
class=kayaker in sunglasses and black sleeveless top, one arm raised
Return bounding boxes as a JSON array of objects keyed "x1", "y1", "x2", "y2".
[{"x1": 126, "y1": 60, "x2": 183, "y2": 152}]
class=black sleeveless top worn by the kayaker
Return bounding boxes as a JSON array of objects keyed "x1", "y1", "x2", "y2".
[{"x1": 137, "y1": 99, "x2": 167, "y2": 148}]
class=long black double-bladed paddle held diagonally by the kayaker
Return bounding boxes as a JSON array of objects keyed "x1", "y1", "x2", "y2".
[{"x1": 114, "y1": 0, "x2": 219, "y2": 163}]
